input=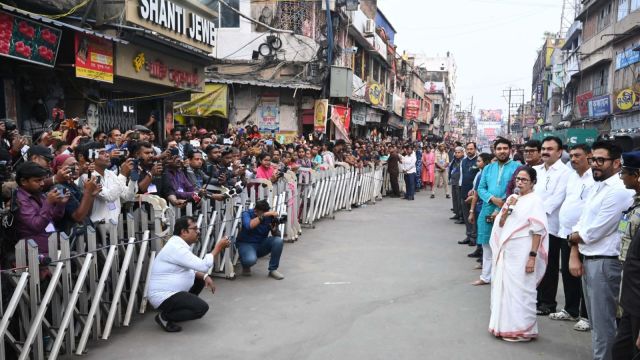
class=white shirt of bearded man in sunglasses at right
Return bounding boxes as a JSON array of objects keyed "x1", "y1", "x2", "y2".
[{"x1": 573, "y1": 174, "x2": 635, "y2": 256}]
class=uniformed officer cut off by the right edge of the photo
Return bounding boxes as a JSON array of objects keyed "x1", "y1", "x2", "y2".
[{"x1": 612, "y1": 151, "x2": 640, "y2": 360}]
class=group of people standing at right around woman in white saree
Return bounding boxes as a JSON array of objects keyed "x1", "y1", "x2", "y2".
[{"x1": 444, "y1": 136, "x2": 640, "y2": 360}]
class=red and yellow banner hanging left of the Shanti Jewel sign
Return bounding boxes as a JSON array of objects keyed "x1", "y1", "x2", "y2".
[{"x1": 75, "y1": 32, "x2": 113, "y2": 84}]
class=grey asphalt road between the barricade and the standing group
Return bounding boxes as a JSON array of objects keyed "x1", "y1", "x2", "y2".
[{"x1": 69, "y1": 192, "x2": 591, "y2": 360}]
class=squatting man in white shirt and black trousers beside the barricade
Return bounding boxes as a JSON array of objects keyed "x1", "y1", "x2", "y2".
[{"x1": 147, "y1": 216, "x2": 230, "y2": 332}]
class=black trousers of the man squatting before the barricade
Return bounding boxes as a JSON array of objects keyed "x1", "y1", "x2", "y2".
[{"x1": 158, "y1": 278, "x2": 209, "y2": 322}]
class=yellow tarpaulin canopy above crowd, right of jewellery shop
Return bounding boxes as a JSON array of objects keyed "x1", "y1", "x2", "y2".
[{"x1": 173, "y1": 84, "x2": 228, "y2": 119}]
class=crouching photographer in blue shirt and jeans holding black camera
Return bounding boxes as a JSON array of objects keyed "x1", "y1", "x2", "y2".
[{"x1": 236, "y1": 200, "x2": 284, "y2": 280}]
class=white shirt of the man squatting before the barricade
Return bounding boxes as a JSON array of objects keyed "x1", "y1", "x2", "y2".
[{"x1": 147, "y1": 235, "x2": 213, "y2": 309}]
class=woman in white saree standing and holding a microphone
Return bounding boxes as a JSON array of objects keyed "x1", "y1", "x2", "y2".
[{"x1": 489, "y1": 168, "x2": 549, "y2": 342}]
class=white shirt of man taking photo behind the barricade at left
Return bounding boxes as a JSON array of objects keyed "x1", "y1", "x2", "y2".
[{"x1": 82, "y1": 170, "x2": 138, "y2": 224}]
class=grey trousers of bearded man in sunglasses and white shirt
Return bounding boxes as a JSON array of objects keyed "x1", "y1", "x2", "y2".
[{"x1": 582, "y1": 259, "x2": 622, "y2": 360}]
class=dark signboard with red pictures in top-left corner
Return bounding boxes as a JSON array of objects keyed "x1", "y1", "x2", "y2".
[{"x1": 0, "y1": 11, "x2": 62, "y2": 67}]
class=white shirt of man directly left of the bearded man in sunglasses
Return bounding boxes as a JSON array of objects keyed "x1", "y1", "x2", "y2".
[{"x1": 558, "y1": 168, "x2": 596, "y2": 239}]
